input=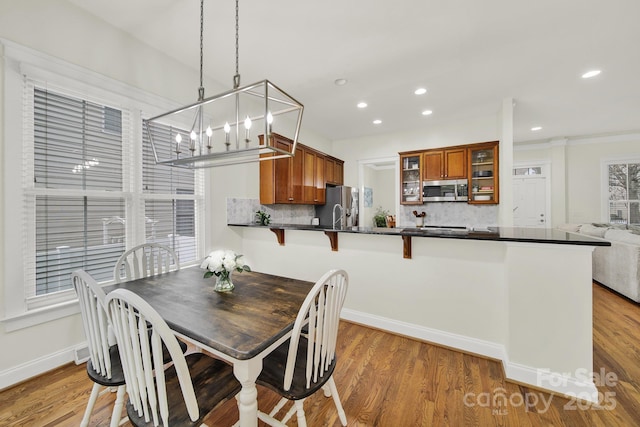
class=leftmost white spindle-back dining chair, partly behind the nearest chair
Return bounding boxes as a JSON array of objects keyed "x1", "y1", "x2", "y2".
[{"x1": 71, "y1": 270, "x2": 125, "y2": 427}]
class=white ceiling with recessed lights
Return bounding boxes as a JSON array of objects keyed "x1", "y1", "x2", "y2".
[{"x1": 68, "y1": 0, "x2": 640, "y2": 143}]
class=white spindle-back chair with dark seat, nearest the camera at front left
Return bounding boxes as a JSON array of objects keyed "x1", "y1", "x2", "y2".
[{"x1": 106, "y1": 289, "x2": 241, "y2": 426}]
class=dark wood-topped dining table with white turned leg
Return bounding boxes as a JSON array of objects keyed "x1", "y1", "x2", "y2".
[{"x1": 104, "y1": 267, "x2": 314, "y2": 427}]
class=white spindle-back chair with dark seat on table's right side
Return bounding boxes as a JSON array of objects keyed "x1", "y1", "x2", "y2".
[{"x1": 256, "y1": 270, "x2": 349, "y2": 427}]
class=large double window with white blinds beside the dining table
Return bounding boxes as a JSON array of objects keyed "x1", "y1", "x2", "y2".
[{"x1": 25, "y1": 83, "x2": 198, "y2": 299}]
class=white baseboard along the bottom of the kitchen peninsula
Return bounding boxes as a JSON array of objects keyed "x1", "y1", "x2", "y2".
[{"x1": 341, "y1": 309, "x2": 598, "y2": 402}]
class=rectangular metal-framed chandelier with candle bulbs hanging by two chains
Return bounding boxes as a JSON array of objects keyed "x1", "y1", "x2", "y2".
[{"x1": 144, "y1": 0, "x2": 304, "y2": 169}]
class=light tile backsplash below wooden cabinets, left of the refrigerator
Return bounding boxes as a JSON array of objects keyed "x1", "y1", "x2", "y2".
[{"x1": 227, "y1": 197, "x2": 316, "y2": 224}]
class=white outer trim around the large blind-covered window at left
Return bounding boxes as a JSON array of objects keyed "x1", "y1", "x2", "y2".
[{"x1": 0, "y1": 39, "x2": 205, "y2": 331}]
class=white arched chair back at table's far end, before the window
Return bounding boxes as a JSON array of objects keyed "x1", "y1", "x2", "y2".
[{"x1": 113, "y1": 243, "x2": 180, "y2": 283}]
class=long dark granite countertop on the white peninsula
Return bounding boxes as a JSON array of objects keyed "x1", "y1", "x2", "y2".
[{"x1": 227, "y1": 223, "x2": 611, "y2": 246}]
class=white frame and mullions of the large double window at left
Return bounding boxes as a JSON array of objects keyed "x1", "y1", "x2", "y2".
[{"x1": 0, "y1": 39, "x2": 205, "y2": 331}]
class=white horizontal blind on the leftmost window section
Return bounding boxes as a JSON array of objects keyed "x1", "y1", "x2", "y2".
[{"x1": 24, "y1": 84, "x2": 129, "y2": 299}]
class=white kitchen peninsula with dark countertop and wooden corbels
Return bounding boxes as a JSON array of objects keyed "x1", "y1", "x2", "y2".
[{"x1": 228, "y1": 223, "x2": 608, "y2": 401}]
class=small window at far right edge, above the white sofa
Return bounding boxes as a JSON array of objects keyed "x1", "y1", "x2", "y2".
[{"x1": 607, "y1": 162, "x2": 640, "y2": 225}]
